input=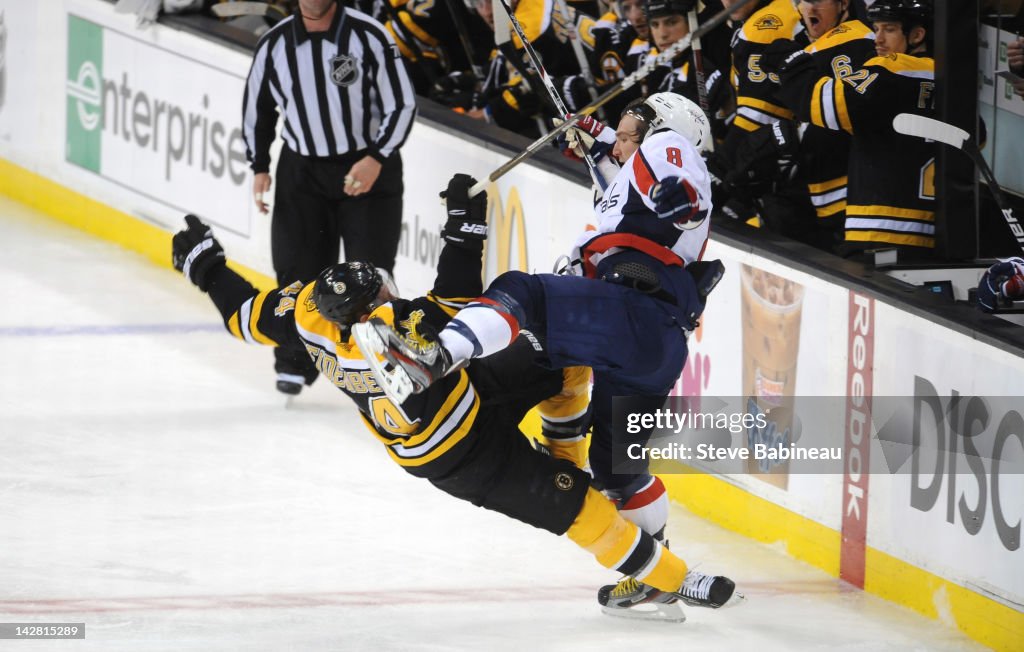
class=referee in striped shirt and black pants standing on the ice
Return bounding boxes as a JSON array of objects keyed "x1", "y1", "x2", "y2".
[{"x1": 242, "y1": 0, "x2": 416, "y2": 394}]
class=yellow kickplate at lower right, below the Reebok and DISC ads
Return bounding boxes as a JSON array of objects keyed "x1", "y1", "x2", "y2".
[{"x1": 658, "y1": 473, "x2": 1024, "y2": 652}]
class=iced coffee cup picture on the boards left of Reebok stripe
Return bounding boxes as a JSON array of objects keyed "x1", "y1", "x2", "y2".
[{"x1": 740, "y1": 265, "x2": 804, "y2": 489}]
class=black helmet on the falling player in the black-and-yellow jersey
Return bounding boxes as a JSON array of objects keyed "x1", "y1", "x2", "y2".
[{"x1": 312, "y1": 258, "x2": 384, "y2": 334}]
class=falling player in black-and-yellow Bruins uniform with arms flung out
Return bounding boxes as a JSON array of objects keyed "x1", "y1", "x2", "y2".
[{"x1": 173, "y1": 175, "x2": 734, "y2": 619}]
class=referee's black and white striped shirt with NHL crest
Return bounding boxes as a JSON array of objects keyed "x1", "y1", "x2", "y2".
[{"x1": 242, "y1": 4, "x2": 416, "y2": 173}]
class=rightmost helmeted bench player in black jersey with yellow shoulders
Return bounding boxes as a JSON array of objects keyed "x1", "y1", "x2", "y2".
[{"x1": 780, "y1": 0, "x2": 935, "y2": 253}]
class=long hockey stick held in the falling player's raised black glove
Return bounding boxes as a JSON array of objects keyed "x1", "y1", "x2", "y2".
[{"x1": 469, "y1": 0, "x2": 754, "y2": 197}]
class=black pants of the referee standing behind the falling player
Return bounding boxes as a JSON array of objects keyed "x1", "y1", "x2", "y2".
[{"x1": 270, "y1": 146, "x2": 403, "y2": 384}]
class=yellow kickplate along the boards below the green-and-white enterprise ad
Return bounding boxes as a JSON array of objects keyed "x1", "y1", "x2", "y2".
[{"x1": 0, "y1": 159, "x2": 278, "y2": 291}]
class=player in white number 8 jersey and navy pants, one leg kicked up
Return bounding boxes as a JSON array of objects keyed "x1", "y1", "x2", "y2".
[{"x1": 353, "y1": 93, "x2": 733, "y2": 614}]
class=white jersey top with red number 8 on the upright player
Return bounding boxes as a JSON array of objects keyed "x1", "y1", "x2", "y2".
[{"x1": 577, "y1": 131, "x2": 712, "y2": 263}]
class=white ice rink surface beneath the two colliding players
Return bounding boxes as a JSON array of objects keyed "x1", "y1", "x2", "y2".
[{"x1": 0, "y1": 199, "x2": 978, "y2": 652}]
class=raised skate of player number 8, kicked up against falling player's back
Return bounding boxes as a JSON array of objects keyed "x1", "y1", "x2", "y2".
[{"x1": 352, "y1": 317, "x2": 454, "y2": 405}]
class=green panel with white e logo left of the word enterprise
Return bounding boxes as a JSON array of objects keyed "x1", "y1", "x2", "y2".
[{"x1": 65, "y1": 15, "x2": 103, "y2": 173}]
